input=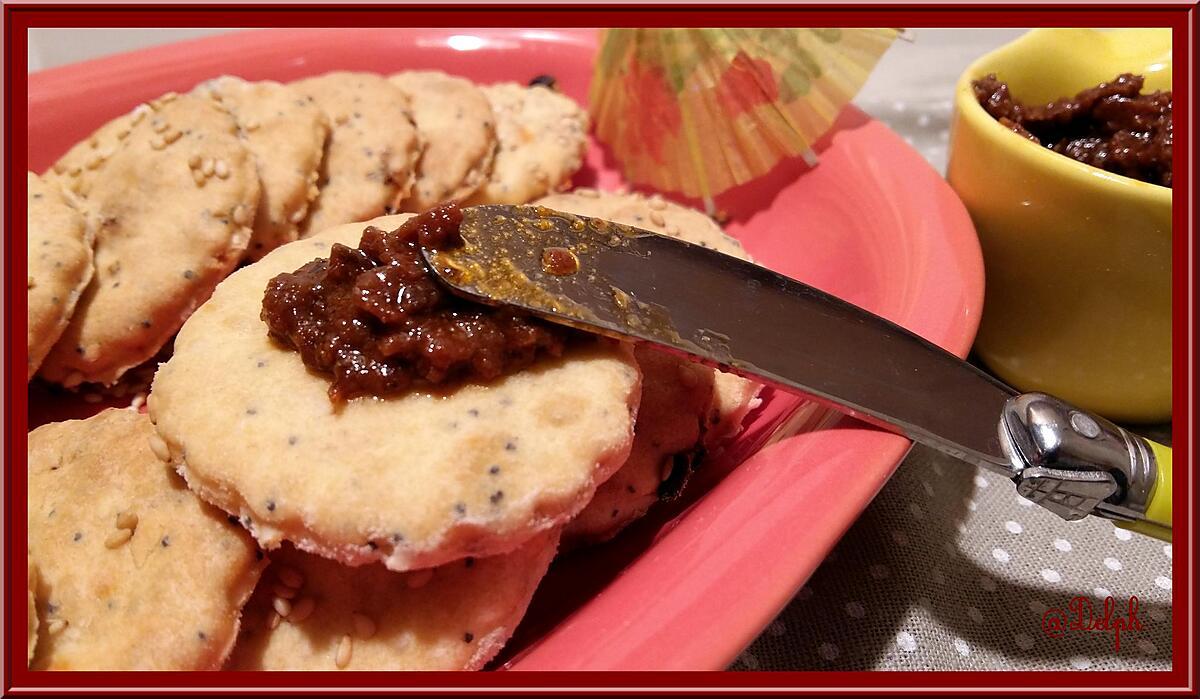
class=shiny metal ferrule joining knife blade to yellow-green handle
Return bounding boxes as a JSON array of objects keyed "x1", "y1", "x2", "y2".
[{"x1": 1000, "y1": 393, "x2": 1170, "y2": 538}]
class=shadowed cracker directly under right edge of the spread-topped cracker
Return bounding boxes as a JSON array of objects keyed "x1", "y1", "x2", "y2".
[{"x1": 563, "y1": 346, "x2": 714, "y2": 545}]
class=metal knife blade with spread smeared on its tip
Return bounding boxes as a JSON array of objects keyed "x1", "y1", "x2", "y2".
[{"x1": 425, "y1": 205, "x2": 1015, "y2": 477}]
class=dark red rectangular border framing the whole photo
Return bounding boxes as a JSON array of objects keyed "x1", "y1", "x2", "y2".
[{"x1": 2, "y1": 2, "x2": 1196, "y2": 694}]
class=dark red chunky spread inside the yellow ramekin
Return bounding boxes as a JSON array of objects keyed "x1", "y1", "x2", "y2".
[{"x1": 973, "y1": 73, "x2": 1174, "y2": 187}]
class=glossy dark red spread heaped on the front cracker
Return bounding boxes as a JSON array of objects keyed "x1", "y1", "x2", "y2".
[{"x1": 262, "y1": 205, "x2": 571, "y2": 402}]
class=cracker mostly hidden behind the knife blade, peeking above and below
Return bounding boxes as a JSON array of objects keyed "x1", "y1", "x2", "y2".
[{"x1": 535, "y1": 189, "x2": 762, "y2": 448}]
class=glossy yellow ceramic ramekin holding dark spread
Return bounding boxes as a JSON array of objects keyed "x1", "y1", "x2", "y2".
[{"x1": 947, "y1": 29, "x2": 1171, "y2": 422}]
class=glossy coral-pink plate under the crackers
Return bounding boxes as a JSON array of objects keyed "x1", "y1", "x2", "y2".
[{"x1": 29, "y1": 29, "x2": 983, "y2": 670}]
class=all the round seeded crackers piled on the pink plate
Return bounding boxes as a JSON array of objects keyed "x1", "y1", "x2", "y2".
[{"x1": 28, "y1": 72, "x2": 758, "y2": 670}]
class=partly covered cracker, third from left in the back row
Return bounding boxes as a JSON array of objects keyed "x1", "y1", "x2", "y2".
[{"x1": 198, "y1": 76, "x2": 329, "y2": 259}]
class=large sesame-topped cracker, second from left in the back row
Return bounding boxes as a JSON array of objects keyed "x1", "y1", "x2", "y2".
[{"x1": 41, "y1": 95, "x2": 259, "y2": 386}]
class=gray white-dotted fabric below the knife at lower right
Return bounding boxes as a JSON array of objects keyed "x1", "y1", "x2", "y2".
[{"x1": 730, "y1": 444, "x2": 1171, "y2": 670}]
